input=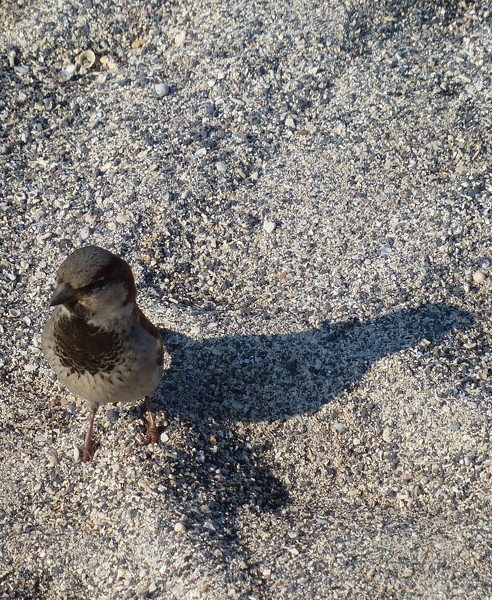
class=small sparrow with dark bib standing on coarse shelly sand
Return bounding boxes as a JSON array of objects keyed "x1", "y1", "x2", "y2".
[{"x1": 41, "y1": 246, "x2": 164, "y2": 462}]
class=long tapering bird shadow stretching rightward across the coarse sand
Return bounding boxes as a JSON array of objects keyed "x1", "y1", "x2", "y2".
[{"x1": 160, "y1": 304, "x2": 473, "y2": 423}]
